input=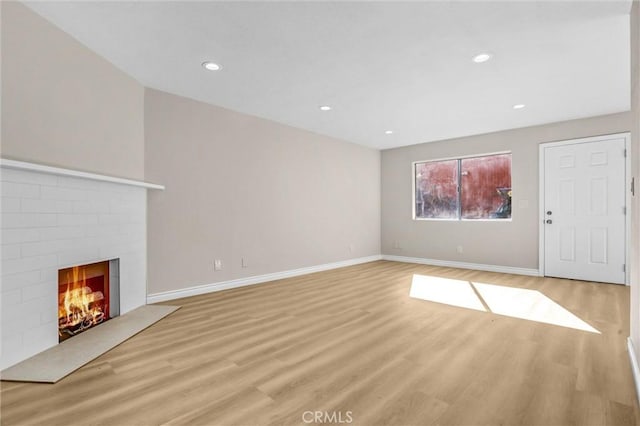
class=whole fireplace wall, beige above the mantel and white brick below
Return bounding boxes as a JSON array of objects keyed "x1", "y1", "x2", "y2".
[{"x1": 0, "y1": 1, "x2": 146, "y2": 368}]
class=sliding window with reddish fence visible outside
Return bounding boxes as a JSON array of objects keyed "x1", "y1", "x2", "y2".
[{"x1": 413, "y1": 154, "x2": 511, "y2": 220}]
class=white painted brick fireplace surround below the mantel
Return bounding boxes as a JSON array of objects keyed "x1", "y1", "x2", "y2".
[{"x1": 0, "y1": 168, "x2": 147, "y2": 369}]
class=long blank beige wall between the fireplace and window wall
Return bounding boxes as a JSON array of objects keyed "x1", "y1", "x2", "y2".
[{"x1": 145, "y1": 89, "x2": 380, "y2": 294}]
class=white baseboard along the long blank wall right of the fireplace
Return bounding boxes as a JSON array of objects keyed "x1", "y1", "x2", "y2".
[{"x1": 147, "y1": 255, "x2": 382, "y2": 304}]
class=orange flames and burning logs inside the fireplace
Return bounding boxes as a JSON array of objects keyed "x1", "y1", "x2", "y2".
[{"x1": 58, "y1": 266, "x2": 105, "y2": 336}]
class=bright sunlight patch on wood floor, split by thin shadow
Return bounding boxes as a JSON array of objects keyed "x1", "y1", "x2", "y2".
[{"x1": 409, "y1": 274, "x2": 600, "y2": 334}]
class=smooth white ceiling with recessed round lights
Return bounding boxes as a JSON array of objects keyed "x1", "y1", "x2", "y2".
[{"x1": 22, "y1": 0, "x2": 631, "y2": 149}]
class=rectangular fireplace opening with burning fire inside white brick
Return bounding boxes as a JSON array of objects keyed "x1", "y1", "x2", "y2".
[{"x1": 58, "y1": 259, "x2": 120, "y2": 342}]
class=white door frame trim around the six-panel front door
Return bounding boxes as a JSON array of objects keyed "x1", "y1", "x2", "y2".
[{"x1": 538, "y1": 132, "x2": 632, "y2": 286}]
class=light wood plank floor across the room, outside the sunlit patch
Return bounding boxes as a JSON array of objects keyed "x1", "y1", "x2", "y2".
[{"x1": 0, "y1": 261, "x2": 638, "y2": 425}]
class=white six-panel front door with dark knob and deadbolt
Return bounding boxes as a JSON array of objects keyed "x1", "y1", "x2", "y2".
[{"x1": 542, "y1": 136, "x2": 626, "y2": 284}]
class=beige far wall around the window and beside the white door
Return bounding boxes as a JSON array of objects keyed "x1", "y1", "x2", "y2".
[{"x1": 381, "y1": 113, "x2": 631, "y2": 270}]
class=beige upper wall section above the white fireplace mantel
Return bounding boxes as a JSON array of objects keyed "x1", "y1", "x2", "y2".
[{"x1": 0, "y1": 1, "x2": 144, "y2": 179}]
